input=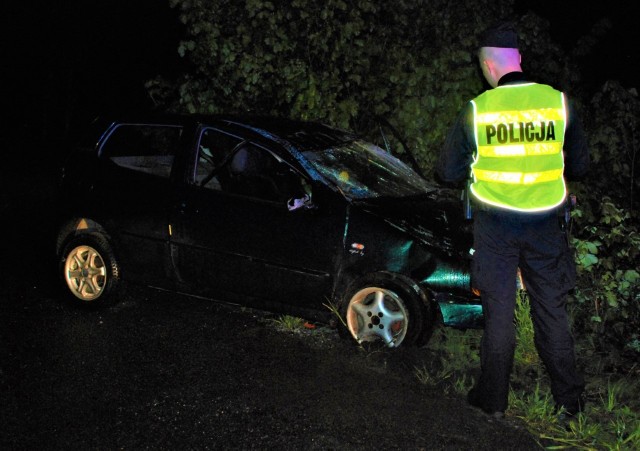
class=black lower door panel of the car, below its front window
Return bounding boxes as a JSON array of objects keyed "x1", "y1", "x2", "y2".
[{"x1": 171, "y1": 183, "x2": 344, "y2": 304}]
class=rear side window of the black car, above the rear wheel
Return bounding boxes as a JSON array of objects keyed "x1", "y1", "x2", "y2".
[{"x1": 101, "y1": 124, "x2": 182, "y2": 178}]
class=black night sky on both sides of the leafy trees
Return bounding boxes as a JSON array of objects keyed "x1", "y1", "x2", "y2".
[{"x1": 3, "y1": 0, "x2": 640, "y2": 150}]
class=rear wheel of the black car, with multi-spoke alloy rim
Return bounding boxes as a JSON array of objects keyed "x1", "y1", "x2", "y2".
[{"x1": 59, "y1": 234, "x2": 122, "y2": 308}]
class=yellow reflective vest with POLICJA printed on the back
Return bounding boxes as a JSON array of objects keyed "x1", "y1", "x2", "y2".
[{"x1": 470, "y1": 83, "x2": 567, "y2": 212}]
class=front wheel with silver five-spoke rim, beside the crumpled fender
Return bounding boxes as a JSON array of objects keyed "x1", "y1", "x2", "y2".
[{"x1": 340, "y1": 273, "x2": 434, "y2": 348}]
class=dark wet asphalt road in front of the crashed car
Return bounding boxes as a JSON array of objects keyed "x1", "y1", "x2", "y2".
[{"x1": 0, "y1": 158, "x2": 540, "y2": 450}]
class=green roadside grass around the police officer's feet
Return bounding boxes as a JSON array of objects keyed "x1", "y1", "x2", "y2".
[{"x1": 415, "y1": 292, "x2": 640, "y2": 450}]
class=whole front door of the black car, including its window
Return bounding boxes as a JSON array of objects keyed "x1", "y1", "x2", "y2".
[{"x1": 171, "y1": 129, "x2": 345, "y2": 306}]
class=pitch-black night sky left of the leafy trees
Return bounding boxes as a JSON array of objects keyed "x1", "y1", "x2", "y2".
[{"x1": 3, "y1": 0, "x2": 183, "y2": 145}]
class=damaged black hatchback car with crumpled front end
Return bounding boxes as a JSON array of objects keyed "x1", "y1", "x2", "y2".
[{"x1": 56, "y1": 115, "x2": 482, "y2": 347}]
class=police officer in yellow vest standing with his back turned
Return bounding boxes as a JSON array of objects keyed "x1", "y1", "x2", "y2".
[{"x1": 436, "y1": 23, "x2": 589, "y2": 417}]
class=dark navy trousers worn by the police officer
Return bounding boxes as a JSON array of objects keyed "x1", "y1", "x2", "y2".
[{"x1": 472, "y1": 211, "x2": 584, "y2": 412}]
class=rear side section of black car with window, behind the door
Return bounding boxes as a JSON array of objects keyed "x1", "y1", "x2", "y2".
[{"x1": 96, "y1": 123, "x2": 182, "y2": 287}]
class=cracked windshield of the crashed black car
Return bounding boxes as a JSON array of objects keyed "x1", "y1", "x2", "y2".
[{"x1": 303, "y1": 141, "x2": 433, "y2": 199}]
